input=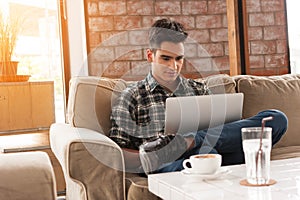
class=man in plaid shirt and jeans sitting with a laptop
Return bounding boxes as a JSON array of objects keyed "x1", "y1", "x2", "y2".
[{"x1": 110, "y1": 19, "x2": 287, "y2": 173}]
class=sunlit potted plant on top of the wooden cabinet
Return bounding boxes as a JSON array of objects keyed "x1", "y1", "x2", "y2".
[{"x1": 0, "y1": 11, "x2": 21, "y2": 76}]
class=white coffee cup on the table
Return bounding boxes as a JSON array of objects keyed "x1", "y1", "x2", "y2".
[{"x1": 183, "y1": 154, "x2": 222, "y2": 174}]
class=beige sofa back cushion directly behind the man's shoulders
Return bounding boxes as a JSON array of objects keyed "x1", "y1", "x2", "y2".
[{"x1": 67, "y1": 74, "x2": 236, "y2": 135}]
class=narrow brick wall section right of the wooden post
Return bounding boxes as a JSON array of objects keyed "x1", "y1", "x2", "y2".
[{"x1": 246, "y1": 0, "x2": 289, "y2": 75}]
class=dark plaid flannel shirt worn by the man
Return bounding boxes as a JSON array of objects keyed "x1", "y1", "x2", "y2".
[{"x1": 110, "y1": 73, "x2": 210, "y2": 150}]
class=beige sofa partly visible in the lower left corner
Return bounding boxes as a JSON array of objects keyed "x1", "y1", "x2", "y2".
[{"x1": 0, "y1": 151, "x2": 57, "y2": 200}]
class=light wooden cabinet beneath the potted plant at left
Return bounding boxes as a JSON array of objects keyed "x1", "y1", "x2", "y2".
[{"x1": 0, "y1": 81, "x2": 55, "y2": 132}]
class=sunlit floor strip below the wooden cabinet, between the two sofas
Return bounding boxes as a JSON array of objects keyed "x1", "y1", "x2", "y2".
[{"x1": 0, "y1": 130, "x2": 66, "y2": 195}]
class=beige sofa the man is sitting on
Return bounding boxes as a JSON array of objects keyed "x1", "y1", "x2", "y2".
[{"x1": 50, "y1": 74, "x2": 300, "y2": 200}]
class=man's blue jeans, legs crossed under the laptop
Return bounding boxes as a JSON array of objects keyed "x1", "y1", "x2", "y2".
[{"x1": 155, "y1": 110, "x2": 288, "y2": 173}]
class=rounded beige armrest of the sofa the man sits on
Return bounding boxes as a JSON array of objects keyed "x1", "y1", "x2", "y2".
[{"x1": 50, "y1": 123, "x2": 125, "y2": 200}]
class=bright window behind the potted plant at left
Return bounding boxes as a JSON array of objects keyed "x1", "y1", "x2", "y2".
[{"x1": 0, "y1": 0, "x2": 65, "y2": 122}]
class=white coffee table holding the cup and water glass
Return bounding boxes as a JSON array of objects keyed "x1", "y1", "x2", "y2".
[{"x1": 148, "y1": 158, "x2": 300, "y2": 200}]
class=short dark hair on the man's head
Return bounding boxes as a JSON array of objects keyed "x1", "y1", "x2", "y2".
[{"x1": 149, "y1": 18, "x2": 188, "y2": 49}]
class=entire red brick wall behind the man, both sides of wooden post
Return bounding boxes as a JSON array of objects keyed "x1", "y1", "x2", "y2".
[{"x1": 85, "y1": 0, "x2": 288, "y2": 79}]
